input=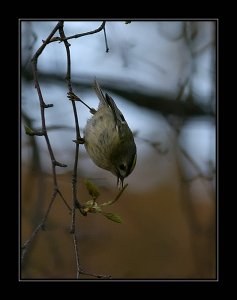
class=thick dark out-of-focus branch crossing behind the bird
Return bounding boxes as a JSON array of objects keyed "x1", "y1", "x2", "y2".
[{"x1": 22, "y1": 70, "x2": 215, "y2": 119}]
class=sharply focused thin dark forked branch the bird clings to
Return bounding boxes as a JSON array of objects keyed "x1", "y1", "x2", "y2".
[{"x1": 21, "y1": 21, "x2": 115, "y2": 278}]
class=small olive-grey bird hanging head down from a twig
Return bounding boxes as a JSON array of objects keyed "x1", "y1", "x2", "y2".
[{"x1": 84, "y1": 79, "x2": 137, "y2": 188}]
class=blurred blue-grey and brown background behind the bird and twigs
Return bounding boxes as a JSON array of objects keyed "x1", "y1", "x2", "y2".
[{"x1": 20, "y1": 20, "x2": 217, "y2": 279}]
